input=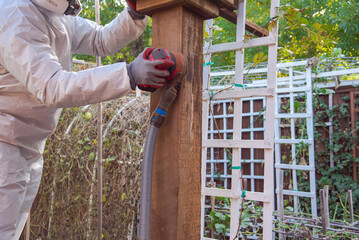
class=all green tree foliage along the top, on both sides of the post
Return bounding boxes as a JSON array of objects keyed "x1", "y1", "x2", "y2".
[{"x1": 75, "y1": 0, "x2": 359, "y2": 67}]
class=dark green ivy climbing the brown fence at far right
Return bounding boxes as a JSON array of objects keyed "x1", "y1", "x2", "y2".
[{"x1": 313, "y1": 89, "x2": 359, "y2": 221}]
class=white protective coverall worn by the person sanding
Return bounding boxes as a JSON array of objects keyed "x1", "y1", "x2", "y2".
[{"x1": 0, "y1": 0, "x2": 147, "y2": 240}]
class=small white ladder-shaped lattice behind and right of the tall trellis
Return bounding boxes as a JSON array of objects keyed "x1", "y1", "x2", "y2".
[{"x1": 275, "y1": 63, "x2": 317, "y2": 217}]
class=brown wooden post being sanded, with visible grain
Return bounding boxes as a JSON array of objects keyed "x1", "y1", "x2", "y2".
[{"x1": 151, "y1": 5, "x2": 203, "y2": 240}]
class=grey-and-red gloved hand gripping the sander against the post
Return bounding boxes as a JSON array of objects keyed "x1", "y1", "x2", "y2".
[{"x1": 127, "y1": 48, "x2": 175, "y2": 92}]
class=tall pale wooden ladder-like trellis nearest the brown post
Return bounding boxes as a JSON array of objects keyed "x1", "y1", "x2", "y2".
[{"x1": 201, "y1": 0, "x2": 279, "y2": 239}]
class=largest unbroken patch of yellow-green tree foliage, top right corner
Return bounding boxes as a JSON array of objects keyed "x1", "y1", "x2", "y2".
[{"x1": 278, "y1": 0, "x2": 359, "y2": 59}]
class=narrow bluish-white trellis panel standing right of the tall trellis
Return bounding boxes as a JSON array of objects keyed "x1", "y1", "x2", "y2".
[{"x1": 274, "y1": 63, "x2": 317, "y2": 217}]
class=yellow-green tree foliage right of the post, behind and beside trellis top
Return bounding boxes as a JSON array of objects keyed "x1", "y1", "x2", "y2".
[{"x1": 205, "y1": 0, "x2": 359, "y2": 67}]
